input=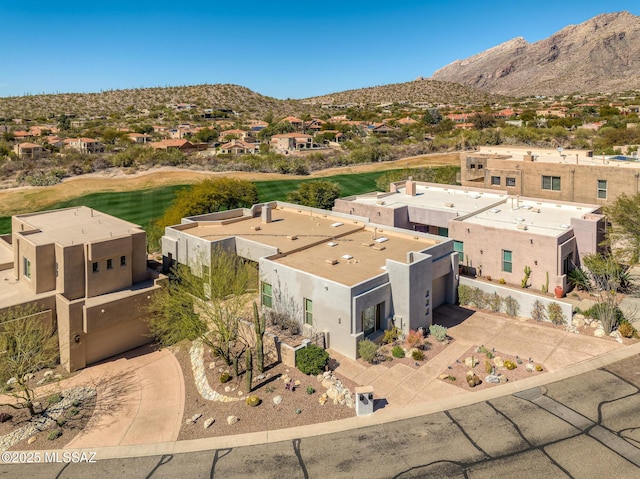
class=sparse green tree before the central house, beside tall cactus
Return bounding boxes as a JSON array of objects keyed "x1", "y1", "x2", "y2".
[{"x1": 149, "y1": 249, "x2": 257, "y2": 366}]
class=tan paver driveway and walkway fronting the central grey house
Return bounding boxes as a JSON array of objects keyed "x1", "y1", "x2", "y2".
[{"x1": 330, "y1": 305, "x2": 624, "y2": 409}]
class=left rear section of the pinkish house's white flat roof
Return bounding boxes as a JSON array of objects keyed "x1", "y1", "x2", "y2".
[{"x1": 343, "y1": 183, "x2": 508, "y2": 216}]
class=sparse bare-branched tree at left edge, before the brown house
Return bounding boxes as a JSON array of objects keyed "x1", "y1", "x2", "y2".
[{"x1": 0, "y1": 305, "x2": 59, "y2": 416}]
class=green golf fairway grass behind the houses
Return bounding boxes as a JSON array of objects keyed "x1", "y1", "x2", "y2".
[{"x1": 0, "y1": 171, "x2": 386, "y2": 234}]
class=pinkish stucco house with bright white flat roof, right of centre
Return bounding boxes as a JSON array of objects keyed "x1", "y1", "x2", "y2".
[{"x1": 334, "y1": 180, "x2": 606, "y2": 290}]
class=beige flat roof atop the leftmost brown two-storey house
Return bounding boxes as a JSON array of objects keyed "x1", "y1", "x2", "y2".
[{"x1": 16, "y1": 206, "x2": 143, "y2": 246}]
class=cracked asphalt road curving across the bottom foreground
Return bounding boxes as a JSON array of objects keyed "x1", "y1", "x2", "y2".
[{"x1": 6, "y1": 355, "x2": 640, "y2": 479}]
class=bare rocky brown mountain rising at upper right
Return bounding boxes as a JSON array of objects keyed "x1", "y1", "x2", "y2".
[{"x1": 431, "y1": 12, "x2": 640, "y2": 96}]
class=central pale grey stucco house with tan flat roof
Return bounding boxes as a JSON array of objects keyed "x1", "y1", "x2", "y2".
[{"x1": 162, "y1": 202, "x2": 458, "y2": 358}]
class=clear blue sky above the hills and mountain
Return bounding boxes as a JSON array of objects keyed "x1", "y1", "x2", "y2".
[{"x1": 0, "y1": 0, "x2": 640, "y2": 99}]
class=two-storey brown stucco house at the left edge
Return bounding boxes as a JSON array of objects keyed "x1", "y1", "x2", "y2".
[{"x1": 0, "y1": 207, "x2": 161, "y2": 371}]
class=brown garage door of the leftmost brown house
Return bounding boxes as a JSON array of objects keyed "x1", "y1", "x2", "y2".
[{"x1": 85, "y1": 319, "x2": 152, "y2": 365}]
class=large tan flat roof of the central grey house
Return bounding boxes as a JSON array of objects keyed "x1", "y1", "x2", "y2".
[{"x1": 180, "y1": 205, "x2": 448, "y2": 286}]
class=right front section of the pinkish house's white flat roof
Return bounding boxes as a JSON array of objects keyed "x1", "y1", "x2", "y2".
[{"x1": 460, "y1": 197, "x2": 600, "y2": 236}]
